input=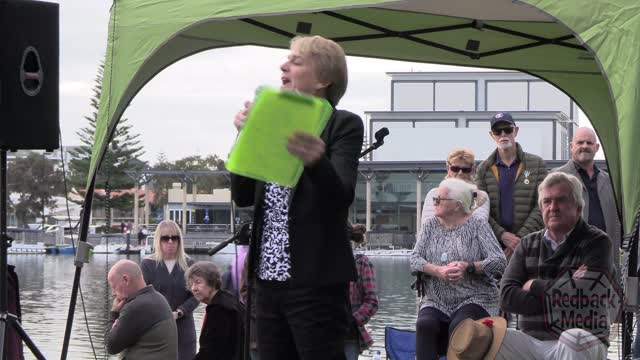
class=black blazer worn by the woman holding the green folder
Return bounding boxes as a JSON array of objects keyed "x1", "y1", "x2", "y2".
[{"x1": 231, "y1": 110, "x2": 364, "y2": 287}]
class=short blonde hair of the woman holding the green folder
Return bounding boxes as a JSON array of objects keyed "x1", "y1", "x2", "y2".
[{"x1": 291, "y1": 35, "x2": 348, "y2": 106}]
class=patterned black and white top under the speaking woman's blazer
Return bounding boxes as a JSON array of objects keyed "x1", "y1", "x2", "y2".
[{"x1": 258, "y1": 183, "x2": 292, "y2": 281}]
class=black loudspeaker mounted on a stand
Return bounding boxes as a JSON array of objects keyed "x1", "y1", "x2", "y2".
[{"x1": 0, "y1": 0, "x2": 60, "y2": 151}]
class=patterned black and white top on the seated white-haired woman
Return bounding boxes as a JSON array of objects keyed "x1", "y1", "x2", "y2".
[{"x1": 411, "y1": 215, "x2": 507, "y2": 316}]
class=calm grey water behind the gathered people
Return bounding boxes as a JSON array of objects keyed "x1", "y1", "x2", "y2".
[{"x1": 9, "y1": 255, "x2": 621, "y2": 359}]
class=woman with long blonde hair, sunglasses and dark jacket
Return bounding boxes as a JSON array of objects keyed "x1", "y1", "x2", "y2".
[{"x1": 140, "y1": 220, "x2": 198, "y2": 360}]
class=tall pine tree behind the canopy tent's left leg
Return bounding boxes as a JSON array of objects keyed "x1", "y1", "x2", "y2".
[{"x1": 69, "y1": 64, "x2": 146, "y2": 229}]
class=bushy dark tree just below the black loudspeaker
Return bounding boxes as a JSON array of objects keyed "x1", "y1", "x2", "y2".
[{"x1": 7, "y1": 152, "x2": 64, "y2": 227}]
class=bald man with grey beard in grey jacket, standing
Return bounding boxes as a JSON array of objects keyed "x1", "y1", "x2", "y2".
[{"x1": 552, "y1": 127, "x2": 622, "y2": 270}]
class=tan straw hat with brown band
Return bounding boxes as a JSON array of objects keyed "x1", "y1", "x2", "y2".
[{"x1": 447, "y1": 316, "x2": 507, "y2": 360}]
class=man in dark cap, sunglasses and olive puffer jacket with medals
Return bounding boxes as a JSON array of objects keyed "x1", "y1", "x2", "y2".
[{"x1": 476, "y1": 112, "x2": 547, "y2": 258}]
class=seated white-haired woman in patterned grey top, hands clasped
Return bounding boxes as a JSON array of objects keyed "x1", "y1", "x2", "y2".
[{"x1": 411, "y1": 179, "x2": 507, "y2": 360}]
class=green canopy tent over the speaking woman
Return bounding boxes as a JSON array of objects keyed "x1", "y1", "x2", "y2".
[{"x1": 60, "y1": 0, "x2": 640, "y2": 358}]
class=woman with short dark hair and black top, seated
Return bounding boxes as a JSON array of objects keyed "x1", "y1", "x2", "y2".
[{"x1": 185, "y1": 261, "x2": 244, "y2": 360}]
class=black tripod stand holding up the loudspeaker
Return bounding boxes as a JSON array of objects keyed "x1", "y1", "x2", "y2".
[{"x1": 0, "y1": 149, "x2": 45, "y2": 360}]
